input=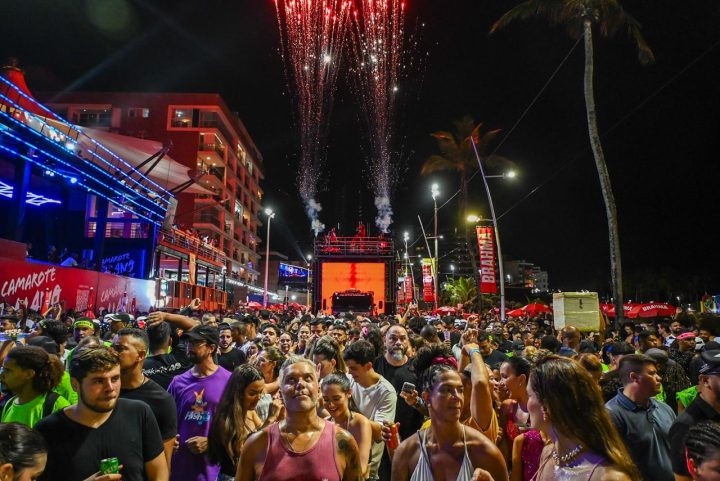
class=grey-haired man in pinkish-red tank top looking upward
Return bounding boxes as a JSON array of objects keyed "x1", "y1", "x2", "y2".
[{"x1": 235, "y1": 356, "x2": 362, "y2": 481}]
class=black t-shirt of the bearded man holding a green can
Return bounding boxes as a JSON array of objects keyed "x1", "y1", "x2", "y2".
[{"x1": 35, "y1": 399, "x2": 163, "y2": 481}]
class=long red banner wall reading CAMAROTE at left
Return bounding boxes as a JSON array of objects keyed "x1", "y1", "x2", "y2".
[{"x1": 0, "y1": 258, "x2": 155, "y2": 313}]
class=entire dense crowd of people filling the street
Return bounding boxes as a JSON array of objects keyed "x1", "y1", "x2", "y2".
[{"x1": 0, "y1": 300, "x2": 720, "y2": 481}]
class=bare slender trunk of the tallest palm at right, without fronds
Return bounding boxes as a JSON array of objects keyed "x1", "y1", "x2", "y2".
[{"x1": 583, "y1": 19, "x2": 624, "y2": 327}]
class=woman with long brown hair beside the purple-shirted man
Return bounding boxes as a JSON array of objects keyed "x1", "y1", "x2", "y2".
[{"x1": 208, "y1": 364, "x2": 265, "y2": 481}]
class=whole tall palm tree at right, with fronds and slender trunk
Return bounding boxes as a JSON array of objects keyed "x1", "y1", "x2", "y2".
[{"x1": 490, "y1": 0, "x2": 654, "y2": 324}]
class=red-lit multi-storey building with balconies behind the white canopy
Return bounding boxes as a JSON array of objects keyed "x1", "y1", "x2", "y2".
[{"x1": 47, "y1": 92, "x2": 263, "y2": 290}]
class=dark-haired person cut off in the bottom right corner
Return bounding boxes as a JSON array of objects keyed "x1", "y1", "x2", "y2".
[{"x1": 685, "y1": 421, "x2": 720, "y2": 481}]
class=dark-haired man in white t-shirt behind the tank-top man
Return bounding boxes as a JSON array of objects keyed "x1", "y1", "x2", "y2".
[{"x1": 343, "y1": 340, "x2": 397, "y2": 480}]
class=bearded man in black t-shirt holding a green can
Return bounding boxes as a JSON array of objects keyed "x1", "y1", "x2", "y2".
[{"x1": 35, "y1": 346, "x2": 168, "y2": 481}]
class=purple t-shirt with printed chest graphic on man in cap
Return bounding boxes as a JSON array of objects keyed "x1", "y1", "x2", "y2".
[{"x1": 168, "y1": 366, "x2": 230, "y2": 481}]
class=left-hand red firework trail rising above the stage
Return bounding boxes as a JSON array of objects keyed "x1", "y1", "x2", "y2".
[{"x1": 275, "y1": 0, "x2": 352, "y2": 235}]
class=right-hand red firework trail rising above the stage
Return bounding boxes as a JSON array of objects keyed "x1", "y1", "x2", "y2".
[{"x1": 351, "y1": 0, "x2": 408, "y2": 232}]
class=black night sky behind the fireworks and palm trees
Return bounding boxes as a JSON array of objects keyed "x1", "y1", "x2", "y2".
[{"x1": 5, "y1": 0, "x2": 720, "y2": 301}]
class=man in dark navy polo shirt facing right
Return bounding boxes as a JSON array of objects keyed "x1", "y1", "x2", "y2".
[{"x1": 605, "y1": 354, "x2": 675, "y2": 481}]
